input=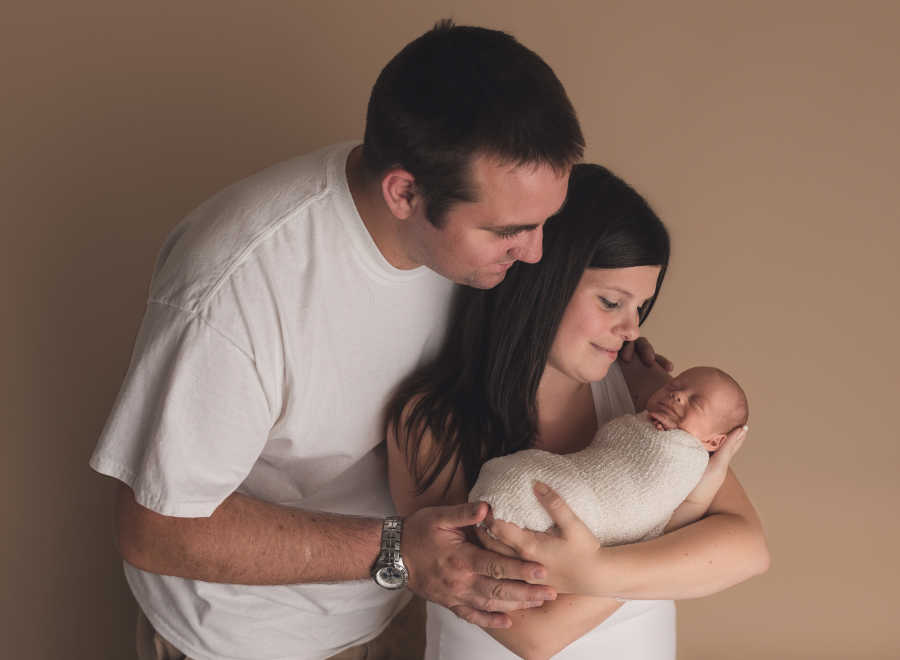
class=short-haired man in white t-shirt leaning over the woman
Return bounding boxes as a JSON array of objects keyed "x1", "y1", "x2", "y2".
[{"x1": 91, "y1": 22, "x2": 583, "y2": 660}]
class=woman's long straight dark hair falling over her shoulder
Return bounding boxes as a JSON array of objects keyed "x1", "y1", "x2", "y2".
[{"x1": 385, "y1": 164, "x2": 669, "y2": 493}]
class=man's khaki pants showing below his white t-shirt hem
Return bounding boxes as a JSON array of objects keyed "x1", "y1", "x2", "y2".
[{"x1": 137, "y1": 598, "x2": 425, "y2": 660}]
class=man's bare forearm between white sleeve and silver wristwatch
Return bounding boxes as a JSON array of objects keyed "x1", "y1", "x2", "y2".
[{"x1": 116, "y1": 485, "x2": 381, "y2": 585}]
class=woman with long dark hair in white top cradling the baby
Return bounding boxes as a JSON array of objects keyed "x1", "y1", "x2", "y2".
[{"x1": 386, "y1": 165, "x2": 768, "y2": 660}]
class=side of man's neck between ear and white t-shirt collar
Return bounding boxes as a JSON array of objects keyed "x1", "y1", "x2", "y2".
[{"x1": 347, "y1": 146, "x2": 419, "y2": 270}]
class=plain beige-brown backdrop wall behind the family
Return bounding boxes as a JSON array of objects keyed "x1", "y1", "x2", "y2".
[{"x1": 0, "y1": 0, "x2": 900, "y2": 659}]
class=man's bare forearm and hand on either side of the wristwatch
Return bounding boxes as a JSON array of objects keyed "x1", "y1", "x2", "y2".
[{"x1": 116, "y1": 476, "x2": 555, "y2": 627}]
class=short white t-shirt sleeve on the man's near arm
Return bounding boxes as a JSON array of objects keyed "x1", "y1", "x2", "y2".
[{"x1": 90, "y1": 302, "x2": 271, "y2": 517}]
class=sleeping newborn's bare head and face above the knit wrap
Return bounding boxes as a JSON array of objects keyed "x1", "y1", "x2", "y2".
[{"x1": 647, "y1": 367, "x2": 740, "y2": 451}]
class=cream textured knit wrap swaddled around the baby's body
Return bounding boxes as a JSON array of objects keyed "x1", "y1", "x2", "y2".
[{"x1": 469, "y1": 412, "x2": 709, "y2": 545}]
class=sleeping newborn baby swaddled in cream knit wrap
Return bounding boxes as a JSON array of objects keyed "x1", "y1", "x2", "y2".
[{"x1": 469, "y1": 367, "x2": 748, "y2": 545}]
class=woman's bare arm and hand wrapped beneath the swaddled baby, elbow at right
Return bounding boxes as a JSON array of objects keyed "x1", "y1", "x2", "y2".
[{"x1": 490, "y1": 470, "x2": 769, "y2": 600}]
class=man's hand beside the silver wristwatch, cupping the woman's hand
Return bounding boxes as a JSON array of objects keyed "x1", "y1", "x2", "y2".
[{"x1": 401, "y1": 502, "x2": 556, "y2": 628}]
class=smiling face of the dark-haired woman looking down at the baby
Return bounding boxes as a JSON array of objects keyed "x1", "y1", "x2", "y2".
[{"x1": 547, "y1": 266, "x2": 660, "y2": 383}]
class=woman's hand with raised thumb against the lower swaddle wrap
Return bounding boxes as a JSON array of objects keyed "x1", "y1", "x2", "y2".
[{"x1": 478, "y1": 482, "x2": 604, "y2": 595}]
